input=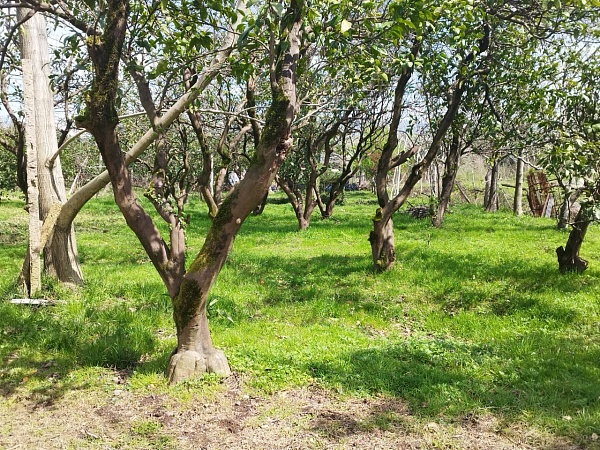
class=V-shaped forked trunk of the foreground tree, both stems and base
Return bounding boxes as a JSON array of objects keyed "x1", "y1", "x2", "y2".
[{"x1": 69, "y1": 0, "x2": 258, "y2": 382}]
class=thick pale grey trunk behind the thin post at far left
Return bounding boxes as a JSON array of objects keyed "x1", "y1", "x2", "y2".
[{"x1": 18, "y1": 8, "x2": 83, "y2": 284}]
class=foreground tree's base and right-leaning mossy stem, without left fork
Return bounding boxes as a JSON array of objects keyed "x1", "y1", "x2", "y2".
[{"x1": 167, "y1": 0, "x2": 303, "y2": 383}]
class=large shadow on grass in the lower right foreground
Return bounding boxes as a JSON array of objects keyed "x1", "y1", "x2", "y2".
[{"x1": 307, "y1": 333, "x2": 600, "y2": 438}]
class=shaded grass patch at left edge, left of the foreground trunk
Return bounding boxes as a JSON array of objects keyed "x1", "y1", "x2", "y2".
[{"x1": 0, "y1": 290, "x2": 166, "y2": 406}]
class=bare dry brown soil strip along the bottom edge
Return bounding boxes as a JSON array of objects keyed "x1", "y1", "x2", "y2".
[{"x1": 0, "y1": 374, "x2": 595, "y2": 450}]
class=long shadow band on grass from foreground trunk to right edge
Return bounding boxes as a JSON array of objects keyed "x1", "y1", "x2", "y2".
[{"x1": 215, "y1": 243, "x2": 600, "y2": 325}]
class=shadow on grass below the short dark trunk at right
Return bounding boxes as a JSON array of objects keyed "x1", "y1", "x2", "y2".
[{"x1": 402, "y1": 244, "x2": 600, "y2": 324}]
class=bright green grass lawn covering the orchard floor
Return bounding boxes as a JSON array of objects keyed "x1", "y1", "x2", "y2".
[{"x1": 0, "y1": 193, "x2": 600, "y2": 440}]
